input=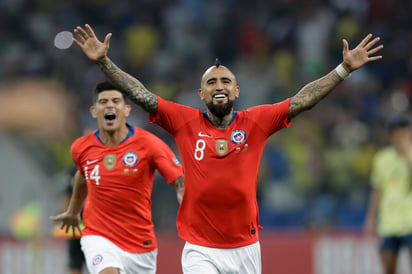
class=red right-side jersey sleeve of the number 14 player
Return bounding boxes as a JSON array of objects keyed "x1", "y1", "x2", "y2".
[{"x1": 153, "y1": 137, "x2": 183, "y2": 184}]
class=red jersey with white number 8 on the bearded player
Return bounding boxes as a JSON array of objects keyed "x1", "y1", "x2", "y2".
[{"x1": 149, "y1": 97, "x2": 290, "y2": 248}]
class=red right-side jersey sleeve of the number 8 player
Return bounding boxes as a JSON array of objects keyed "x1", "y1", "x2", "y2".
[{"x1": 246, "y1": 98, "x2": 291, "y2": 136}]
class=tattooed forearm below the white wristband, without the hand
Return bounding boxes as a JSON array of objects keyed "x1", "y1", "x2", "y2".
[{"x1": 289, "y1": 70, "x2": 342, "y2": 118}]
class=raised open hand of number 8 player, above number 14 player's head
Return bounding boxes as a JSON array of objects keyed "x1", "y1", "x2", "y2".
[{"x1": 73, "y1": 24, "x2": 112, "y2": 62}]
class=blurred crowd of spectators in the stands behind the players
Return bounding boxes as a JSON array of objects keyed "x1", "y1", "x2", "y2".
[{"x1": 0, "y1": 0, "x2": 412, "y2": 237}]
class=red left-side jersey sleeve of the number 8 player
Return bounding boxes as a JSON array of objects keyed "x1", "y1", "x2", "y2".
[{"x1": 149, "y1": 96, "x2": 197, "y2": 135}]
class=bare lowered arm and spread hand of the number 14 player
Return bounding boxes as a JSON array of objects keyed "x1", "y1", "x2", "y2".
[{"x1": 50, "y1": 171, "x2": 87, "y2": 236}]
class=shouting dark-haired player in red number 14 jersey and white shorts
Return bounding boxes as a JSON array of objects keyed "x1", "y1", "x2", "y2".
[{"x1": 50, "y1": 82, "x2": 184, "y2": 274}]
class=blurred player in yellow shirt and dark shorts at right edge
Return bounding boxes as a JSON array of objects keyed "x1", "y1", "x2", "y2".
[{"x1": 365, "y1": 115, "x2": 412, "y2": 274}]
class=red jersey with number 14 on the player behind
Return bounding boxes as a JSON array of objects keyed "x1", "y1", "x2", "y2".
[{"x1": 71, "y1": 126, "x2": 183, "y2": 253}]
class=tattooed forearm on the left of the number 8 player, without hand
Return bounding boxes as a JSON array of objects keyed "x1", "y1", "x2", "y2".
[{"x1": 96, "y1": 58, "x2": 158, "y2": 115}]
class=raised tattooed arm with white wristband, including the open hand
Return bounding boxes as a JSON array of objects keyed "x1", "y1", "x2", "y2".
[{"x1": 289, "y1": 34, "x2": 383, "y2": 118}]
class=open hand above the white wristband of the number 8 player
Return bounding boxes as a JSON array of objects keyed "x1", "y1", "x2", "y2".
[{"x1": 342, "y1": 34, "x2": 383, "y2": 72}]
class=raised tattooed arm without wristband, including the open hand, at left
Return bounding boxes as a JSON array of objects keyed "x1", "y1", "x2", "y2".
[{"x1": 74, "y1": 24, "x2": 157, "y2": 115}]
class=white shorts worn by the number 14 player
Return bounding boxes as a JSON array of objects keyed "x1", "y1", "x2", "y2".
[{"x1": 80, "y1": 235, "x2": 157, "y2": 274}]
